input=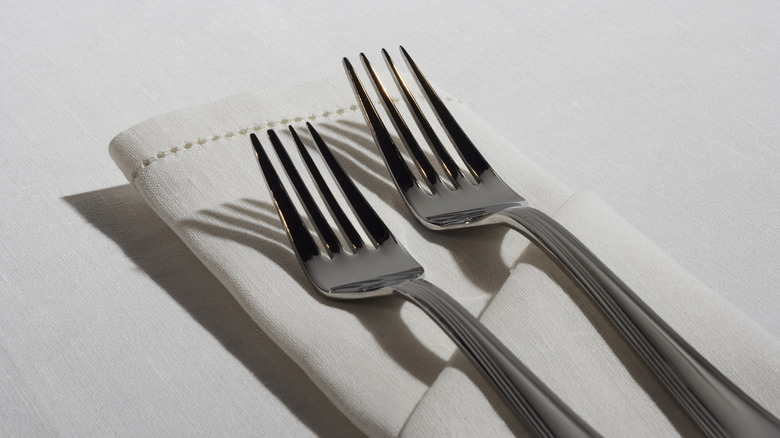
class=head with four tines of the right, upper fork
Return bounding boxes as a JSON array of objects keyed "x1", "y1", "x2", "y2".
[{"x1": 344, "y1": 47, "x2": 528, "y2": 230}]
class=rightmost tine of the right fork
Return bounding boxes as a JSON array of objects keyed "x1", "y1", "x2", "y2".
[{"x1": 400, "y1": 46, "x2": 490, "y2": 181}]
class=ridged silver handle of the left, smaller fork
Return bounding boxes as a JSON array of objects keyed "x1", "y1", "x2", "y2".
[{"x1": 392, "y1": 279, "x2": 598, "y2": 437}]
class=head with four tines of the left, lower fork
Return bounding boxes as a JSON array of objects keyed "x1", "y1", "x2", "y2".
[{"x1": 250, "y1": 123, "x2": 423, "y2": 299}]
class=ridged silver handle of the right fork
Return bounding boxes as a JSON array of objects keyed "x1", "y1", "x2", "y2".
[{"x1": 504, "y1": 207, "x2": 780, "y2": 437}]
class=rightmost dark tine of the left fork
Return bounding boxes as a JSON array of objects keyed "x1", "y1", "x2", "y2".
[{"x1": 306, "y1": 122, "x2": 390, "y2": 246}]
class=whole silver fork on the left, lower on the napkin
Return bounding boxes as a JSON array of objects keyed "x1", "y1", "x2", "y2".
[{"x1": 250, "y1": 123, "x2": 597, "y2": 437}]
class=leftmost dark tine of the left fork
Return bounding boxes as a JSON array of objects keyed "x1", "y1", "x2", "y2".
[{"x1": 249, "y1": 133, "x2": 320, "y2": 261}]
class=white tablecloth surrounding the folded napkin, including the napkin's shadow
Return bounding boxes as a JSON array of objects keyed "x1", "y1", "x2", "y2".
[{"x1": 0, "y1": 0, "x2": 780, "y2": 436}]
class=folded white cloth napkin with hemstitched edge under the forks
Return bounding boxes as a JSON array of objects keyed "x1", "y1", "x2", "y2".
[{"x1": 110, "y1": 78, "x2": 780, "y2": 436}]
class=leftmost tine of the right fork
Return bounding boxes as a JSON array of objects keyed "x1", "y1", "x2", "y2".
[{"x1": 343, "y1": 58, "x2": 415, "y2": 192}]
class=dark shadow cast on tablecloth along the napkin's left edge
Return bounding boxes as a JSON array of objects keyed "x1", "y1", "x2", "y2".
[{"x1": 63, "y1": 185, "x2": 362, "y2": 436}]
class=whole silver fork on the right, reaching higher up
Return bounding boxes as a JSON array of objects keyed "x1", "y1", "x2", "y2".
[{"x1": 343, "y1": 47, "x2": 780, "y2": 436}]
